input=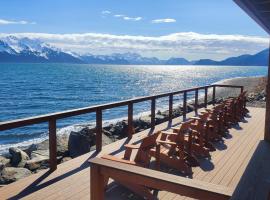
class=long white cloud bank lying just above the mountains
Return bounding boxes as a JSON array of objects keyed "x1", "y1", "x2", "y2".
[{"x1": 0, "y1": 32, "x2": 269, "y2": 60}]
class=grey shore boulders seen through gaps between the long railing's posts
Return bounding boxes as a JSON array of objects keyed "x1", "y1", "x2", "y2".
[{"x1": 0, "y1": 99, "x2": 207, "y2": 185}]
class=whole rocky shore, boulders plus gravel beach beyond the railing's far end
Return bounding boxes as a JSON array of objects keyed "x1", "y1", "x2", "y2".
[{"x1": 0, "y1": 77, "x2": 267, "y2": 185}]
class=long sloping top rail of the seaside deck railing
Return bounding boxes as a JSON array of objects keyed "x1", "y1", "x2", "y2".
[{"x1": 0, "y1": 84, "x2": 242, "y2": 131}]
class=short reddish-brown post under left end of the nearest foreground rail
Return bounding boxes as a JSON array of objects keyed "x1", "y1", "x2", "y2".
[{"x1": 90, "y1": 164, "x2": 105, "y2": 200}]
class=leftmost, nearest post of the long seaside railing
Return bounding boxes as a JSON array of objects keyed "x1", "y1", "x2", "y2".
[{"x1": 49, "y1": 119, "x2": 57, "y2": 171}]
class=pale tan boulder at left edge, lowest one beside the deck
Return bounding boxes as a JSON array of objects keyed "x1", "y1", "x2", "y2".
[{"x1": 0, "y1": 167, "x2": 31, "y2": 184}]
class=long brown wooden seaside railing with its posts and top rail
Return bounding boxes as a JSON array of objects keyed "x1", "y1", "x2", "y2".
[{"x1": 0, "y1": 84, "x2": 244, "y2": 170}]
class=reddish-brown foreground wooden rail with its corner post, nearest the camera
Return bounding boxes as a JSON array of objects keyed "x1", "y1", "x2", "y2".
[{"x1": 89, "y1": 157, "x2": 233, "y2": 200}]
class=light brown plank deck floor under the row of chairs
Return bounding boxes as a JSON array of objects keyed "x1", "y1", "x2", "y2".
[{"x1": 0, "y1": 108, "x2": 270, "y2": 200}]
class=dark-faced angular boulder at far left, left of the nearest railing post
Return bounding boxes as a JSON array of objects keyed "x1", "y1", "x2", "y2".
[{"x1": 9, "y1": 147, "x2": 30, "y2": 167}]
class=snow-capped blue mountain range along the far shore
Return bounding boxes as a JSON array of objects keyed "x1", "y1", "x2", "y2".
[{"x1": 0, "y1": 36, "x2": 269, "y2": 66}]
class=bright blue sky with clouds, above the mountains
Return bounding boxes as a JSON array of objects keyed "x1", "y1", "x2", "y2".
[{"x1": 0, "y1": 0, "x2": 268, "y2": 59}]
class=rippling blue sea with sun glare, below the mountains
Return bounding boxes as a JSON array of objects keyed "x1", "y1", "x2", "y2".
[{"x1": 0, "y1": 64, "x2": 267, "y2": 152}]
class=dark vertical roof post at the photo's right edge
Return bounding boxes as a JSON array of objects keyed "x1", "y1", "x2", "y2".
[{"x1": 264, "y1": 42, "x2": 270, "y2": 142}]
